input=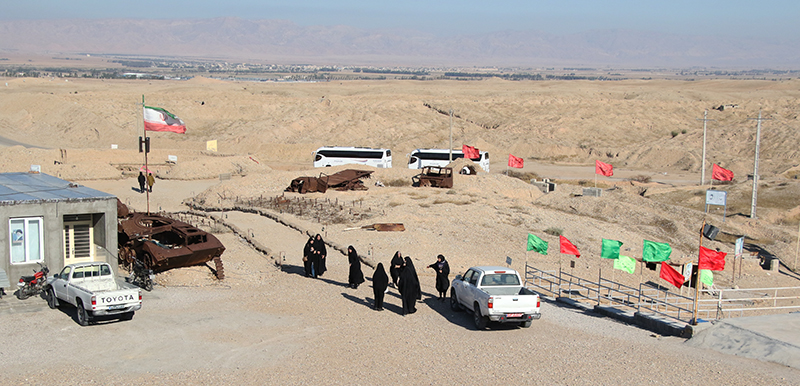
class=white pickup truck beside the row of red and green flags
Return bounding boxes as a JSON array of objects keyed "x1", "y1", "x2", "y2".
[{"x1": 450, "y1": 267, "x2": 542, "y2": 330}]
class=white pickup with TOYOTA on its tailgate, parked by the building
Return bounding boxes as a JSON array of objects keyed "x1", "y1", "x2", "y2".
[{"x1": 45, "y1": 262, "x2": 142, "y2": 326}]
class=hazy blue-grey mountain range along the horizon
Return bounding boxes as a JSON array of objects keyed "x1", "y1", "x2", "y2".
[{"x1": 0, "y1": 17, "x2": 800, "y2": 69}]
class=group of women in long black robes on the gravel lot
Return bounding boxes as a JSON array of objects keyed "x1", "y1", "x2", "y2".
[{"x1": 303, "y1": 238, "x2": 450, "y2": 315}]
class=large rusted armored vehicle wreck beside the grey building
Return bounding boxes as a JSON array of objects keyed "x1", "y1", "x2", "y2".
[{"x1": 117, "y1": 207, "x2": 225, "y2": 279}]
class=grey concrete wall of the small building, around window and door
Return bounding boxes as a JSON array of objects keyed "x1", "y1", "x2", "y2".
[{"x1": 0, "y1": 197, "x2": 117, "y2": 284}]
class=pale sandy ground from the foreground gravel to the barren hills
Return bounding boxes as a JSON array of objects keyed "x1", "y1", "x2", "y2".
[{"x1": 0, "y1": 79, "x2": 800, "y2": 385}]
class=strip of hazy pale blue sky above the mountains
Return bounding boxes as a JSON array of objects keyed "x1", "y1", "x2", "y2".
[{"x1": 6, "y1": 0, "x2": 800, "y2": 39}]
